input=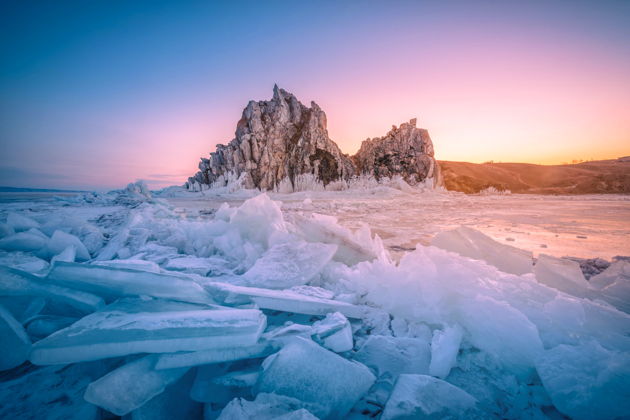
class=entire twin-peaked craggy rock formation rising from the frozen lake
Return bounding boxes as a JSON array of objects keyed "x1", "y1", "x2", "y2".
[{"x1": 187, "y1": 85, "x2": 439, "y2": 191}]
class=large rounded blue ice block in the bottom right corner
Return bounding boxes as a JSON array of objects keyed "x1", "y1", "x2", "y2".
[{"x1": 536, "y1": 341, "x2": 630, "y2": 420}]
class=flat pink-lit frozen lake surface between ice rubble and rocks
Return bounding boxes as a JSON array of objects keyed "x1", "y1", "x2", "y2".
[{"x1": 168, "y1": 190, "x2": 630, "y2": 260}]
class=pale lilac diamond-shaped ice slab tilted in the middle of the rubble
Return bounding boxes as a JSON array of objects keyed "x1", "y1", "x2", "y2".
[{"x1": 239, "y1": 242, "x2": 337, "y2": 289}]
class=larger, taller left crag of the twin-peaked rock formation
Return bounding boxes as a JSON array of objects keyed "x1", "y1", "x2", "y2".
[{"x1": 189, "y1": 86, "x2": 354, "y2": 190}]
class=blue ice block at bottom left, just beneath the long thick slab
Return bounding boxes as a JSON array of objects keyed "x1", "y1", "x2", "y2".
[{"x1": 84, "y1": 355, "x2": 188, "y2": 416}]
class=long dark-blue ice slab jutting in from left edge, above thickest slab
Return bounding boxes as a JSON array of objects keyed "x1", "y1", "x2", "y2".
[{"x1": 0, "y1": 266, "x2": 105, "y2": 313}]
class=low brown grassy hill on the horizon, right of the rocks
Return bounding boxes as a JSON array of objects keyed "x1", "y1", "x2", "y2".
[{"x1": 439, "y1": 157, "x2": 630, "y2": 194}]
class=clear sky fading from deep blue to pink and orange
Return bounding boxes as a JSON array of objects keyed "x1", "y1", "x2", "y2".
[{"x1": 0, "y1": 0, "x2": 630, "y2": 190}]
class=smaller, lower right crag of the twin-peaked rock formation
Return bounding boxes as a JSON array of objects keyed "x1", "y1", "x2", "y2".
[{"x1": 352, "y1": 118, "x2": 439, "y2": 185}]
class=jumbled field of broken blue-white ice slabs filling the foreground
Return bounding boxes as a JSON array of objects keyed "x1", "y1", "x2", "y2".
[{"x1": 0, "y1": 191, "x2": 630, "y2": 420}]
